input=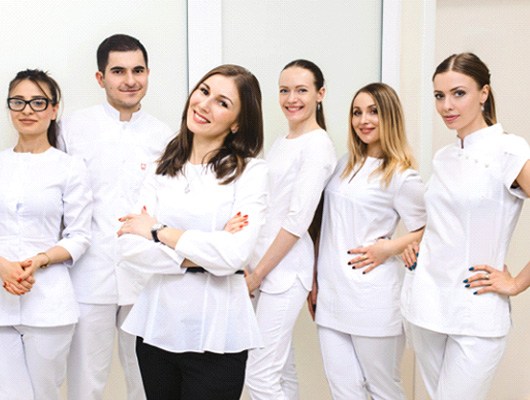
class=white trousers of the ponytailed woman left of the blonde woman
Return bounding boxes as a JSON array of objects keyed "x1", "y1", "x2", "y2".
[{"x1": 246, "y1": 279, "x2": 308, "y2": 400}]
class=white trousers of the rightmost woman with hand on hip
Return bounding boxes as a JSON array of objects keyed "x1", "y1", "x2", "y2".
[{"x1": 405, "y1": 323, "x2": 507, "y2": 400}]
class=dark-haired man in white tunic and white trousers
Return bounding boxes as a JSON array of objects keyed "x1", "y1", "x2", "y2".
[{"x1": 59, "y1": 34, "x2": 172, "y2": 400}]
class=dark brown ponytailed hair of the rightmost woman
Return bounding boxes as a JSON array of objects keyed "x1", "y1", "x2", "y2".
[{"x1": 432, "y1": 53, "x2": 497, "y2": 125}]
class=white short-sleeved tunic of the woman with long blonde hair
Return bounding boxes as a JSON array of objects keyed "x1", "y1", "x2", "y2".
[{"x1": 316, "y1": 156, "x2": 426, "y2": 337}]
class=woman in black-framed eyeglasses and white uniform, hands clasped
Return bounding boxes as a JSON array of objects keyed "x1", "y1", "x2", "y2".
[{"x1": 0, "y1": 70, "x2": 92, "y2": 400}]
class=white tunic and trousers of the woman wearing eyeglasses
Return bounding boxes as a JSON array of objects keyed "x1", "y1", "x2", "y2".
[{"x1": 0, "y1": 147, "x2": 92, "y2": 400}]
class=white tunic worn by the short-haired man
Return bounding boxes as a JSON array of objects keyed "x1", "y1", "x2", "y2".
[{"x1": 59, "y1": 103, "x2": 174, "y2": 305}]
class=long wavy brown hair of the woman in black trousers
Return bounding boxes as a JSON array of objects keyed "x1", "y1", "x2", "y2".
[{"x1": 156, "y1": 64, "x2": 263, "y2": 184}]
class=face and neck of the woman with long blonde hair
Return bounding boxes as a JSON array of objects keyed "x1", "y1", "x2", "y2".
[{"x1": 351, "y1": 92, "x2": 381, "y2": 157}]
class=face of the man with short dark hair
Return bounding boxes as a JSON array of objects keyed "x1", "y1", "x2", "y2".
[{"x1": 96, "y1": 50, "x2": 149, "y2": 121}]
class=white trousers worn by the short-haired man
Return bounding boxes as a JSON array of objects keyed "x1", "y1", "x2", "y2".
[{"x1": 68, "y1": 303, "x2": 145, "y2": 400}]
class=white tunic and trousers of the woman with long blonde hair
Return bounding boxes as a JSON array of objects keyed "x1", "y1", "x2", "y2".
[{"x1": 316, "y1": 156, "x2": 426, "y2": 400}]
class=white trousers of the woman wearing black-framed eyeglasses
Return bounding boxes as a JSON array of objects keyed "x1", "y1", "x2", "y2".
[{"x1": 0, "y1": 325, "x2": 75, "y2": 400}]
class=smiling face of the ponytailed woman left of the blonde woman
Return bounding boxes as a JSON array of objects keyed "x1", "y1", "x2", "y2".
[{"x1": 279, "y1": 67, "x2": 325, "y2": 131}]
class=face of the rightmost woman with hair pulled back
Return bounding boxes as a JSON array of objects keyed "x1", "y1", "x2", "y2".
[{"x1": 433, "y1": 71, "x2": 489, "y2": 138}]
